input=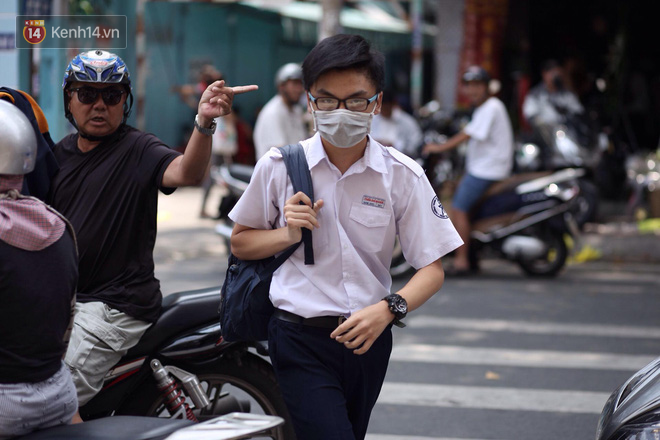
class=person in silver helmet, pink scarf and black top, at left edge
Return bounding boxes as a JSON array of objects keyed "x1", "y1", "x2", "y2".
[{"x1": 0, "y1": 99, "x2": 78, "y2": 439}]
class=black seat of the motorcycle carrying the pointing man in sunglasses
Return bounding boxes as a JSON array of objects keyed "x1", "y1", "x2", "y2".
[{"x1": 126, "y1": 287, "x2": 220, "y2": 358}]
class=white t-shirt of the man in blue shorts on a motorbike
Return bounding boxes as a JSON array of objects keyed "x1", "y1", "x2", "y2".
[{"x1": 463, "y1": 97, "x2": 513, "y2": 180}]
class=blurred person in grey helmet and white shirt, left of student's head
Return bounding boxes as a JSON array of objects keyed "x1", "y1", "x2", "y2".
[{"x1": 253, "y1": 63, "x2": 308, "y2": 160}]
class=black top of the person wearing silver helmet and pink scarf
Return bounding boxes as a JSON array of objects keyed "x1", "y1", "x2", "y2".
[{"x1": 0, "y1": 231, "x2": 78, "y2": 383}]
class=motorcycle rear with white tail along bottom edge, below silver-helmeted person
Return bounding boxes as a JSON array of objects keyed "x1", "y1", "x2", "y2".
[{"x1": 17, "y1": 413, "x2": 284, "y2": 440}]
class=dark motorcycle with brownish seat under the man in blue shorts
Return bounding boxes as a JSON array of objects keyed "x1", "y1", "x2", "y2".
[{"x1": 390, "y1": 168, "x2": 583, "y2": 277}]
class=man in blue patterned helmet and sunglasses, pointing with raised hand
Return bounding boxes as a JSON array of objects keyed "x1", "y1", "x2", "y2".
[{"x1": 48, "y1": 50, "x2": 257, "y2": 420}]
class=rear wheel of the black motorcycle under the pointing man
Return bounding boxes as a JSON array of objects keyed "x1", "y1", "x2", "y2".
[{"x1": 117, "y1": 353, "x2": 296, "y2": 440}]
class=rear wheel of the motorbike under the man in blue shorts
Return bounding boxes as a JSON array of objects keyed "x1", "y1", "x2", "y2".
[{"x1": 518, "y1": 228, "x2": 568, "y2": 277}]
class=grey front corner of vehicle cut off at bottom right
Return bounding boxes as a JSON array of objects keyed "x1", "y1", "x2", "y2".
[{"x1": 596, "y1": 358, "x2": 660, "y2": 440}]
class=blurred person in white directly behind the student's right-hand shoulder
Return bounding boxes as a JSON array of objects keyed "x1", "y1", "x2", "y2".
[{"x1": 371, "y1": 90, "x2": 423, "y2": 157}]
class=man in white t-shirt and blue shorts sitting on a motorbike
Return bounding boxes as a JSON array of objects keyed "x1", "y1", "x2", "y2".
[{"x1": 423, "y1": 66, "x2": 514, "y2": 275}]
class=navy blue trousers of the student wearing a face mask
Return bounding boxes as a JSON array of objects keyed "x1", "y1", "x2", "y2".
[{"x1": 268, "y1": 318, "x2": 392, "y2": 440}]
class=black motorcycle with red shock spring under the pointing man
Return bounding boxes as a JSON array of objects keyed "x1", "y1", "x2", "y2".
[{"x1": 66, "y1": 288, "x2": 295, "y2": 439}]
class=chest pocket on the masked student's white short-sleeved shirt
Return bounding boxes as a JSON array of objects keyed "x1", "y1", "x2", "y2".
[{"x1": 349, "y1": 202, "x2": 392, "y2": 252}]
